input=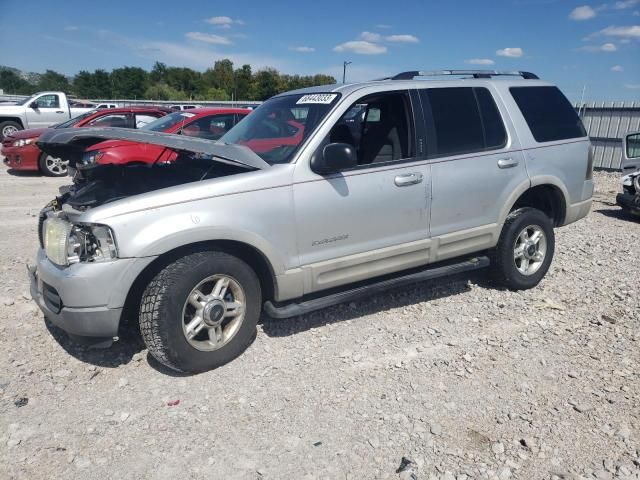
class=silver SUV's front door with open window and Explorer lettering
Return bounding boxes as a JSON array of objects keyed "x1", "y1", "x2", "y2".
[{"x1": 293, "y1": 91, "x2": 431, "y2": 293}]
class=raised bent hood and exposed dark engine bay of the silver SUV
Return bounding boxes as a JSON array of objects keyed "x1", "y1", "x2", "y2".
[{"x1": 38, "y1": 128, "x2": 269, "y2": 211}]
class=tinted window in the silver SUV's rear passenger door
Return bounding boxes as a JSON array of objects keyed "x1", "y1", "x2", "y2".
[{"x1": 420, "y1": 87, "x2": 507, "y2": 156}]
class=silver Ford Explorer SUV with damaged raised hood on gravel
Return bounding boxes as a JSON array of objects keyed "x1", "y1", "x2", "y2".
[{"x1": 30, "y1": 71, "x2": 593, "y2": 372}]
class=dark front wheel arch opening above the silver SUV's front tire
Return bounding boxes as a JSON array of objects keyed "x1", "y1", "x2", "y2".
[{"x1": 121, "y1": 240, "x2": 277, "y2": 330}]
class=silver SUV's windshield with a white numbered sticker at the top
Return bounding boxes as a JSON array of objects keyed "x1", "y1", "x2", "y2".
[{"x1": 220, "y1": 93, "x2": 340, "y2": 164}]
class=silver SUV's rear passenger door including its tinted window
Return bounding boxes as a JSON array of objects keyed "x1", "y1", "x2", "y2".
[{"x1": 420, "y1": 85, "x2": 529, "y2": 261}]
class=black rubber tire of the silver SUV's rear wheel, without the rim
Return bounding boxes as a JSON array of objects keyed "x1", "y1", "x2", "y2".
[{"x1": 490, "y1": 207, "x2": 555, "y2": 290}]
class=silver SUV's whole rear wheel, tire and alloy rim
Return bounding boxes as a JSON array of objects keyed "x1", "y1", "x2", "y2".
[{"x1": 491, "y1": 207, "x2": 555, "y2": 290}]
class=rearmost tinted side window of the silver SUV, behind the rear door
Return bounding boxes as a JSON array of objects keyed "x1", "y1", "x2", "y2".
[{"x1": 509, "y1": 87, "x2": 587, "y2": 143}]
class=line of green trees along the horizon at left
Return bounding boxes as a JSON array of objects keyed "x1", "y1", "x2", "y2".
[{"x1": 0, "y1": 59, "x2": 336, "y2": 100}]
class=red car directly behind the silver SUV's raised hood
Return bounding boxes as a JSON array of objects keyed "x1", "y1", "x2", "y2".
[{"x1": 76, "y1": 108, "x2": 251, "y2": 170}]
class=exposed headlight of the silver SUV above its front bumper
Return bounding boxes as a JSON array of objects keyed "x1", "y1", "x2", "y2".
[{"x1": 44, "y1": 217, "x2": 118, "y2": 266}]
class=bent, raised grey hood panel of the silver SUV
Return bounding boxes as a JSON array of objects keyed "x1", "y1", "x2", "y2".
[{"x1": 37, "y1": 127, "x2": 270, "y2": 170}]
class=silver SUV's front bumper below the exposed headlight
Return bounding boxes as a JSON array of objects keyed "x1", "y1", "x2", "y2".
[{"x1": 29, "y1": 249, "x2": 155, "y2": 337}]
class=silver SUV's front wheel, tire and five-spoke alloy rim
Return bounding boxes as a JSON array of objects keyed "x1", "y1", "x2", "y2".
[{"x1": 140, "y1": 252, "x2": 262, "y2": 373}]
